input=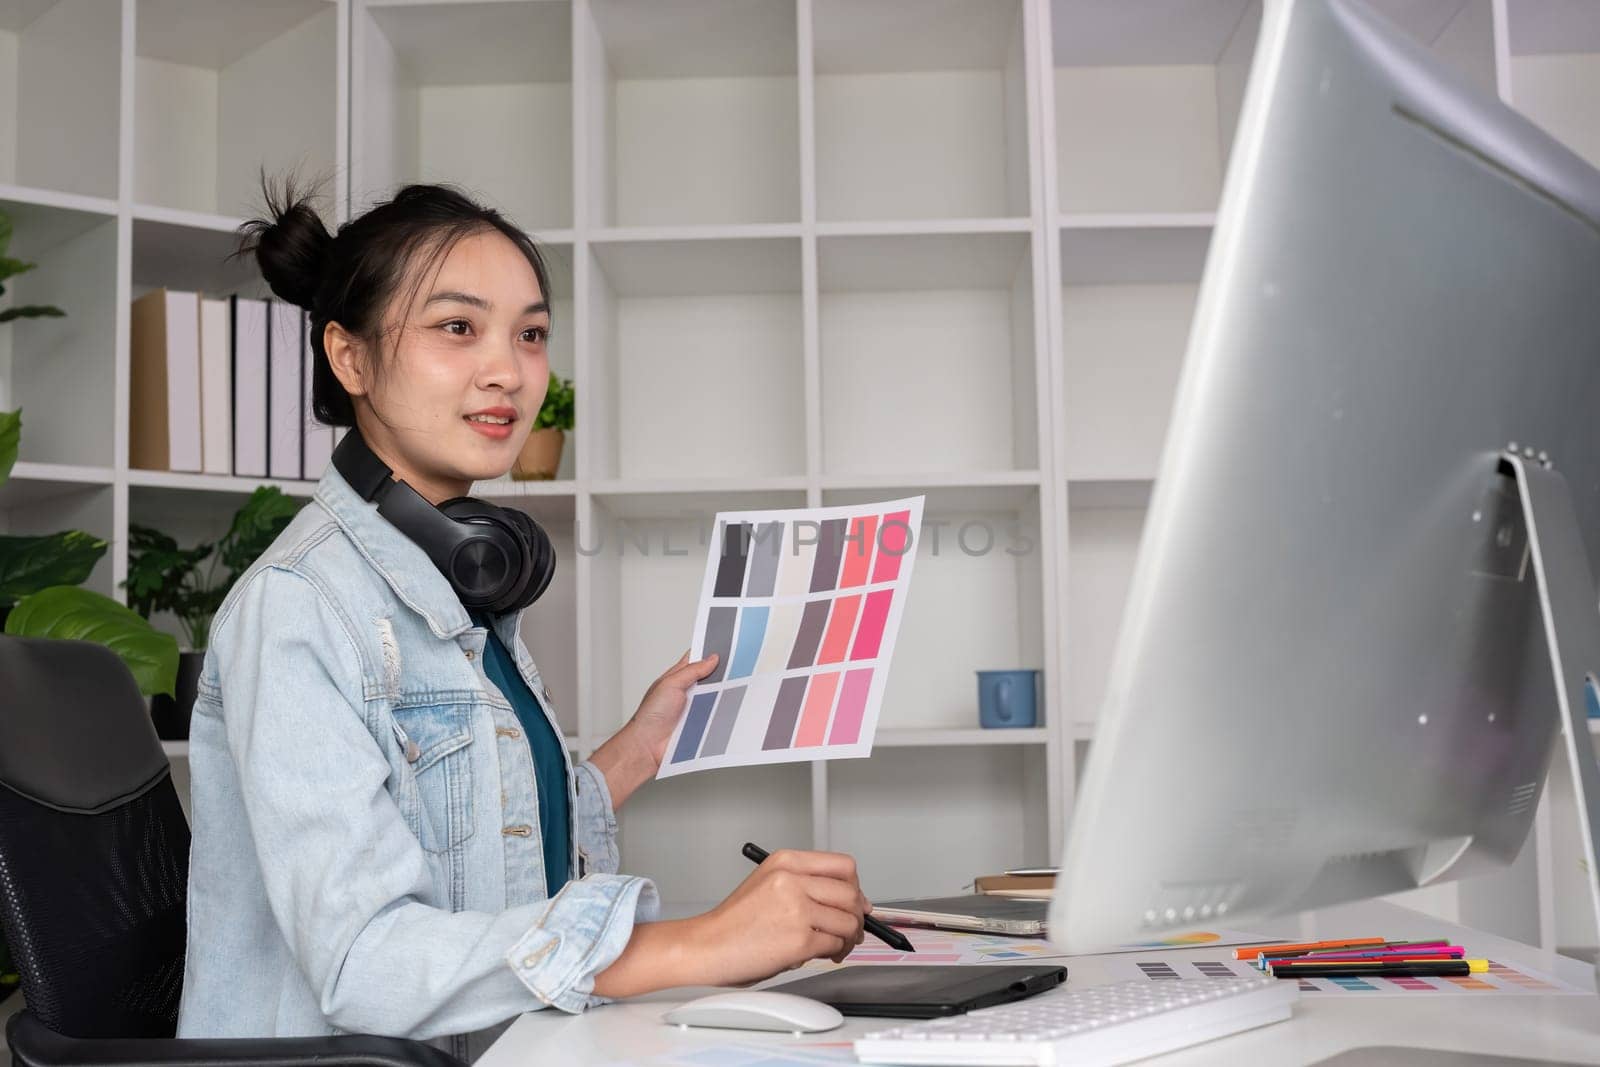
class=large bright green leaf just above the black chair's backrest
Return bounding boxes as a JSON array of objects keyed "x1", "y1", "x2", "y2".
[{"x1": 5, "y1": 585, "x2": 178, "y2": 696}]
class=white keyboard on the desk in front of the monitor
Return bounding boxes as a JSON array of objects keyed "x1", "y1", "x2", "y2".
[{"x1": 856, "y1": 976, "x2": 1299, "y2": 1067}]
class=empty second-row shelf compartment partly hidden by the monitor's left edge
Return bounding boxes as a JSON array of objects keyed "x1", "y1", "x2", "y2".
[{"x1": 1061, "y1": 227, "x2": 1211, "y2": 482}]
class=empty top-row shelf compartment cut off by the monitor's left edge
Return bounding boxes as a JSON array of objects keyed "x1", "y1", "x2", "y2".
[{"x1": 1050, "y1": 0, "x2": 1261, "y2": 213}]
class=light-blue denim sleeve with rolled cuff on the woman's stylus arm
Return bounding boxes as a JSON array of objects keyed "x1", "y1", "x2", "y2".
[{"x1": 211, "y1": 566, "x2": 658, "y2": 1040}]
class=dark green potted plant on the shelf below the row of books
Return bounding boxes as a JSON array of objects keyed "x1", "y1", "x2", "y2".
[{"x1": 123, "y1": 485, "x2": 301, "y2": 741}]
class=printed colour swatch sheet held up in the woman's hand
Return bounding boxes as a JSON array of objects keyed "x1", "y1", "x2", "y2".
[{"x1": 658, "y1": 496, "x2": 923, "y2": 777}]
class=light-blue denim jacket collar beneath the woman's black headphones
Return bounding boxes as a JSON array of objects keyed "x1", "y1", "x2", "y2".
[{"x1": 315, "y1": 464, "x2": 474, "y2": 638}]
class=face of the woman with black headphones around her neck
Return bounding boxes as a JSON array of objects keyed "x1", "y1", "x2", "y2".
[{"x1": 347, "y1": 230, "x2": 550, "y2": 504}]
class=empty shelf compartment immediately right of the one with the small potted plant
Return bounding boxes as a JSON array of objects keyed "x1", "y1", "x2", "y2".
[{"x1": 578, "y1": 238, "x2": 806, "y2": 480}]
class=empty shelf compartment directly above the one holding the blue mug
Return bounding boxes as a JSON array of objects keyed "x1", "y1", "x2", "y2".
[{"x1": 818, "y1": 234, "x2": 1038, "y2": 477}]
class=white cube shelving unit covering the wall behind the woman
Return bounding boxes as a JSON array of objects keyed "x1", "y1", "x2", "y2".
[{"x1": 9, "y1": 0, "x2": 1600, "y2": 937}]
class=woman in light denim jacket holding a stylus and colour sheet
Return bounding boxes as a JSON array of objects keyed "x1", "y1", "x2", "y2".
[{"x1": 179, "y1": 186, "x2": 867, "y2": 1059}]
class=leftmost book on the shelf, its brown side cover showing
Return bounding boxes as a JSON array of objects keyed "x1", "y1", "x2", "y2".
[{"x1": 128, "y1": 290, "x2": 202, "y2": 474}]
